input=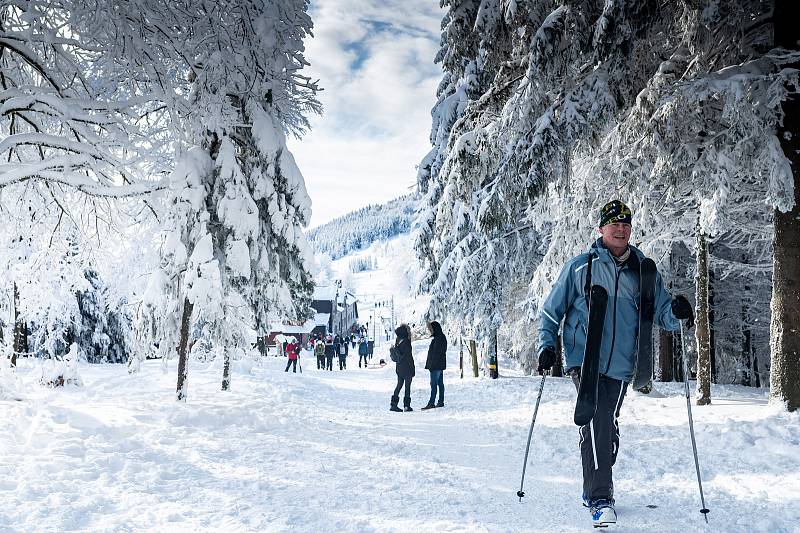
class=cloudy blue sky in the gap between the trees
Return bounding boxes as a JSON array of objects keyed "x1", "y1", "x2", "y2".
[{"x1": 289, "y1": 0, "x2": 443, "y2": 227}]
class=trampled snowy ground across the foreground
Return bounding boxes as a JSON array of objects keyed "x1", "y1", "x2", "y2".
[{"x1": 0, "y1": 342, "x2": 800, "y2": 533}]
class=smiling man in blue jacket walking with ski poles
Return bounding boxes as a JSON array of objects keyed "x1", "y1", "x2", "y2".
[{"x1": 539, "y1": 200, "x2": 694, "y2": 526}]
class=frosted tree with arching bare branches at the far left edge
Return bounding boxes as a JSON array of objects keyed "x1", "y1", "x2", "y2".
[{"x1": 0, "y1": 0, "x2": 168, "y2": 368}]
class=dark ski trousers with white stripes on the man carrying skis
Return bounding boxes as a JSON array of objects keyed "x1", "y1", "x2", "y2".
[{"x1": 571, "y1": 369, "x2": 628, "y2": 501}]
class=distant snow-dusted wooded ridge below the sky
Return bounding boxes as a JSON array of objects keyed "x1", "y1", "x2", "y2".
[{"x1": 308, "y1": 194, "x2": 417, "y2": 259}]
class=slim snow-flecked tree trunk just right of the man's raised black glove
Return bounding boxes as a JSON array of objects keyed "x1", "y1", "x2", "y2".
[{"x1": 695, "y1": 228, "x2": 711, "y2": 405}]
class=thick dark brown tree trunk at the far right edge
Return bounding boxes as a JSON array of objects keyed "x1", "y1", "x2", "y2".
[{"x1": 770, "y1": 0, "x2": 800, "y2": 411}]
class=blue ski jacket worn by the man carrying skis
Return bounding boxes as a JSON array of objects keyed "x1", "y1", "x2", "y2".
[{"x1": 539, "y1": 239, "x2": 680, "y2": 381}]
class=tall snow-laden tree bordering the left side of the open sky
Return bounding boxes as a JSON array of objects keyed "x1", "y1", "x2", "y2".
[{"x1": 110, "y1": 0, "x2": 320, "y2": 398}]
